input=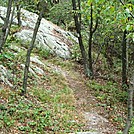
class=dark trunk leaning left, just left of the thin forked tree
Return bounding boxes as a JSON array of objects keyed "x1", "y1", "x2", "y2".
[{"x1": 72, "y1": 0, "x2": 90, "y2": 76}]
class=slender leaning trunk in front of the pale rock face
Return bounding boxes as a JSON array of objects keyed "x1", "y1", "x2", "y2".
[{"x1": 22, "y1": 1, "x2": 45, "y2": 95}]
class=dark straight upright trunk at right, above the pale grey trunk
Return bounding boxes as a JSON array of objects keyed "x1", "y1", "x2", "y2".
[{"x1": 122, "y1": 30, "x2": 127, "y2": 89}]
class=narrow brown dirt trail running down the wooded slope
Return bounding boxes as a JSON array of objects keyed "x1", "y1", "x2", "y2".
[{"x1": 61, "y1": 70, "x2": 117, "y2": 134}]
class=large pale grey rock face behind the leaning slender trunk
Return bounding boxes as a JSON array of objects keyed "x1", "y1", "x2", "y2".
[{"x1": 0, "y1": 6, "x2": 77, "y2": 59}]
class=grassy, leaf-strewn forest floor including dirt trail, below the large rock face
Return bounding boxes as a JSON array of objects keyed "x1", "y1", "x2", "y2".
[{"x1": 0, "y1": 58, "x2": 126, "y2": 134}]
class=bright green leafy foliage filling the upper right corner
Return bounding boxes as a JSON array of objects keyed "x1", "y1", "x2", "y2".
[{"x1": 81, "y1": 0, "x2": 134, "y2": 64}]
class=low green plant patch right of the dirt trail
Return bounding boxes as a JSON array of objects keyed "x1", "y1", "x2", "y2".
[{"x1": 88, "y1": 81, "x2": 127, "y2": 106}]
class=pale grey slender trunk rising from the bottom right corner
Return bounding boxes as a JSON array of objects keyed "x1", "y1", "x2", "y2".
[{"x1": 123, "y1": 74, "x2": 134, "y2": 134}]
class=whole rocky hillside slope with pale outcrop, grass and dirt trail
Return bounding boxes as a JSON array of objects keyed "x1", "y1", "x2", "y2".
[{"x1": 0, "y1": 7, "x2": 126, "y2": 134}]
